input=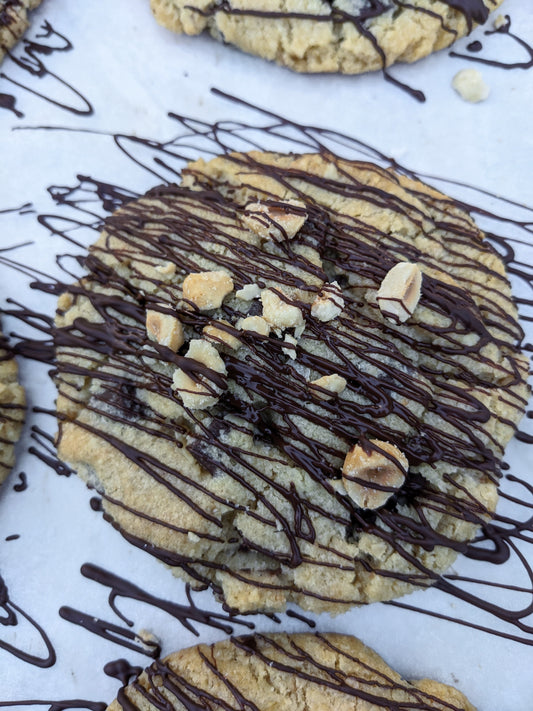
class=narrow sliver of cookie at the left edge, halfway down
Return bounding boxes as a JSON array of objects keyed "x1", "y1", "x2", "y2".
[{"x1": 0, "y1": 324, "x2": 26, "y2": 484}]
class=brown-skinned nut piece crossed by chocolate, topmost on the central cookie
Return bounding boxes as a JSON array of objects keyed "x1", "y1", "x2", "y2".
[{"x1": 242, "y1": 200, "x2": 307, "y2": 242}]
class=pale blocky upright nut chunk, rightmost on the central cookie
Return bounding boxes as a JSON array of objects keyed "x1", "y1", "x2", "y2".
[{"x1": 376, "y1": 262, "x2": 422, "y2": 323}]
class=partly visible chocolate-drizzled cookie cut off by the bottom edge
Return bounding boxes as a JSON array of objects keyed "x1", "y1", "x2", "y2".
[{"x1": 108, "y1": 634, "x2": 475, "y2": 711}]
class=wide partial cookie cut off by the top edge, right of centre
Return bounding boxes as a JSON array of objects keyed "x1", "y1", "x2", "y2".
[{"x1": 151, "y1": 0, "x2": 502, "y2": 74}]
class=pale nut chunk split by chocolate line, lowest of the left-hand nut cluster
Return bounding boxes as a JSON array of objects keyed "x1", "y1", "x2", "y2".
[{"x1": 172, "y1": 338, "x2": 226, "y2": 410}]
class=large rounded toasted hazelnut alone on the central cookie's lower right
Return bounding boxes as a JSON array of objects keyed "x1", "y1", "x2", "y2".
[{"x1": 342, "y1": 439, "x2": 409, "y2": 509}]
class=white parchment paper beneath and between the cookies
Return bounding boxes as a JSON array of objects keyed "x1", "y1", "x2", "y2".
[{"x1": 0, "y1": 0, "x2": 533, "y2": 711}]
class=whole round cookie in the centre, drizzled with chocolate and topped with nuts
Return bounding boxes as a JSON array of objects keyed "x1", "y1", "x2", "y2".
[{"x1": 56, "y1": 152, "x2": 528, "y2": 613}]
